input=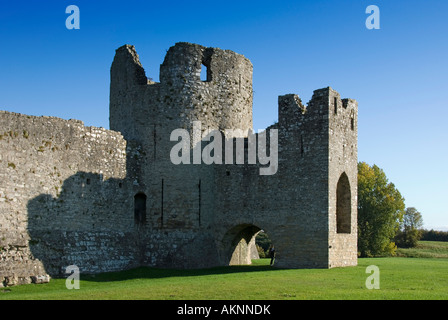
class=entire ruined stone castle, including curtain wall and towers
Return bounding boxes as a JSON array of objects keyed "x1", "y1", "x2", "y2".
[{"x1": 0, "y1": 43, "x2": 357, "y2": 286}]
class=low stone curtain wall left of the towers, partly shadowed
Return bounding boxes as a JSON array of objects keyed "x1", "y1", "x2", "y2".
[{"x1": 0, "y1": 111, "x2": 132, "y2": 284}]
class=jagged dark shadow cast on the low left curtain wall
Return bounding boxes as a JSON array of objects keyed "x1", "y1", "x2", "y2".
[{"x1": 27, "y1": 172, "x2": 142, "y2": 276}]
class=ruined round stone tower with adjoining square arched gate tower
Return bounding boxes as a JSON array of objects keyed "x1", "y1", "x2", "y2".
[{"x1": 110, "y1": 43, "x2": 357, "y2": 267}]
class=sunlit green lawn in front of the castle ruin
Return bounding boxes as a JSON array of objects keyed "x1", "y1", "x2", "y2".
[{"x1": 0, "y1": 242, "x2": 448, "y2": 300}]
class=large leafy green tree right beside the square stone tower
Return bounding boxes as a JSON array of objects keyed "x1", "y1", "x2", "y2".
[{"x1": 358, "y1": 162, "x2": 405, "y2": 257}]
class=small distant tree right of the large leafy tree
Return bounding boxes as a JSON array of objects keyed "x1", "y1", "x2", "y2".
[{"x1": 395, "y1": 207, "x2": 423, "y2": 248}]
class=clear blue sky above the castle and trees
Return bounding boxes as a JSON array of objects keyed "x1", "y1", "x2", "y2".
[{"x1": 0, "y1": 0, "x2": 448, "y2": 228}]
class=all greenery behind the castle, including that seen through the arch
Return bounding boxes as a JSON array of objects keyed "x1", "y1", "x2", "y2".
[{"x1": 256, "y1": 162, "x2": 442, "y2": 258}]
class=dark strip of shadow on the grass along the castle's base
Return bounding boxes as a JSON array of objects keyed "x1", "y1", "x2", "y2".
[{"x1": 81, "y1": 263, "x2": 282, "y2": 282}]
